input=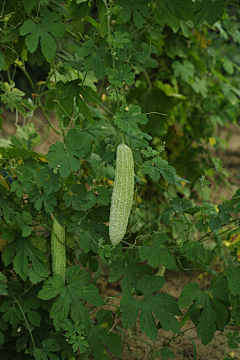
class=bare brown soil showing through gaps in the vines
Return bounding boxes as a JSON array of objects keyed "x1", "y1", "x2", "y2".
[{"x1": 0, "y1": 112, "x2": 240, "y2": 360}]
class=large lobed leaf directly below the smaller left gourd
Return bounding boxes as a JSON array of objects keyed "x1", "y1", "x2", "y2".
[{"x1": 38, "y1": 265, "x2": 104, "y2": 331}]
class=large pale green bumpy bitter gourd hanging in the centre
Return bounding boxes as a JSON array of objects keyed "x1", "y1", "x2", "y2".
[{"x1": 109, "y1": 144, "x2": 134, "y2": 246}]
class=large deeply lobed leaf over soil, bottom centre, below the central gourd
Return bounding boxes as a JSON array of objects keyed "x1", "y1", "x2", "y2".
[{"x1": 120, "y1": 275, "x2": 181, "y2": 341}]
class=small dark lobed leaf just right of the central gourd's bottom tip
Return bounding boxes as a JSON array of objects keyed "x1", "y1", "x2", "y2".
[{"x1": 139, "y1": 232, "x2": 176, "y2": 270}]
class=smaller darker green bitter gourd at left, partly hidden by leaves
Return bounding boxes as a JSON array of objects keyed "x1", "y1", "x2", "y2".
[{"x1": 51, "y1": 219, "x2": 66, "y2": 282}]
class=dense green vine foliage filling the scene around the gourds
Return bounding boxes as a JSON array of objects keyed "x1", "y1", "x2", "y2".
[{"x1": 0, "y1": 0, "x2": 240, "y2": 360}]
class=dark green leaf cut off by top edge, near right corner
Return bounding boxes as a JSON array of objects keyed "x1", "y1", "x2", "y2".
[{"x1": 192, "y1": 0, "x2": 226, "y2": 25}]
